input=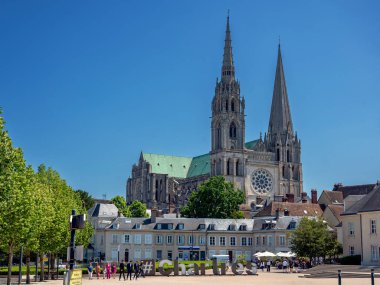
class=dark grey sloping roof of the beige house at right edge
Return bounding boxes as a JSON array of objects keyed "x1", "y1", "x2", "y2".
[{"x1": 342, "y1": 184, "x2": 380, "y2": 215}]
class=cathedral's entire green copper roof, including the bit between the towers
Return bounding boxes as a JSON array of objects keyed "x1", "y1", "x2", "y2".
[{"x1": 142, "y1": 140, "x2": 259, "y2": 178}]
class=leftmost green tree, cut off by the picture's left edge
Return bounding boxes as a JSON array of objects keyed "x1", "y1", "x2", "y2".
[{"x1": 0, "y1": 112, "x2": 37, "y2": 284}]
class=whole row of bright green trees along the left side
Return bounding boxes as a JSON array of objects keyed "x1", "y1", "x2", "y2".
[{"x1": 0, "y1": 113, "x2": 93, "y2": 284}]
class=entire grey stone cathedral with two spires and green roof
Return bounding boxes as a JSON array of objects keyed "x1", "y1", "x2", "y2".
[{"x1": 126, "y1": 17, "x2": 303, "y2": 212}]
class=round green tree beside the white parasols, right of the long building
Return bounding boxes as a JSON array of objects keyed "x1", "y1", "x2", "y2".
[{"x1": 290, "y1": 217, "x2": 335, "y2": 259}]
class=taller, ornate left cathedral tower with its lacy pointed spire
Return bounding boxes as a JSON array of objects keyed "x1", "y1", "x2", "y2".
[{"x1": 210, "y1": 16, "x2": 245, "y2": 188}]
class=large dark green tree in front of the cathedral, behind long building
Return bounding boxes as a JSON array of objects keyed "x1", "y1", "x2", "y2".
[{"x1": 181, "y1": 176, "x2": 245, "y2": 219}]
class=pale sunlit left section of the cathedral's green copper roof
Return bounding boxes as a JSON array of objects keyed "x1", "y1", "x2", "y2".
[{"x1": 143, "y1": 153, "x2": 192, "y2": 178}]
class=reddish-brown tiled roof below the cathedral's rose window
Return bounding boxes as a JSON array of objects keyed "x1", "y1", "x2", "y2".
[{"x1": 255, "y1": 202, "x2": 323, "y2": 217}]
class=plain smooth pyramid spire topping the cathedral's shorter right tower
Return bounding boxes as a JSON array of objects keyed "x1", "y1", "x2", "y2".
[{"x1": 268, "y1": 44, "x2": 293, "y2": 135}]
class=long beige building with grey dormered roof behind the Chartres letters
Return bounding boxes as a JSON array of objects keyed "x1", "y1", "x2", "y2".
[{"x1": 89, "y1": 204, "x2": 301, "y2": 261}]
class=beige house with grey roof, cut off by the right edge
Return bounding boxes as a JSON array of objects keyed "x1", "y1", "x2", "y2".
[{"x1": 341, "y1": 183, "x2": 380, "y2": 265}]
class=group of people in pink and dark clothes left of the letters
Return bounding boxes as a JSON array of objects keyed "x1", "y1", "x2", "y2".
[{"x1": 87, "y1": 260, "x2": 145, "y2": 280}]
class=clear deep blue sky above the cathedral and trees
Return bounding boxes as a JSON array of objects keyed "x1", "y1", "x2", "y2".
[{"x1": 0, "y1": 0, "x2": 380, "y2": 198}]
